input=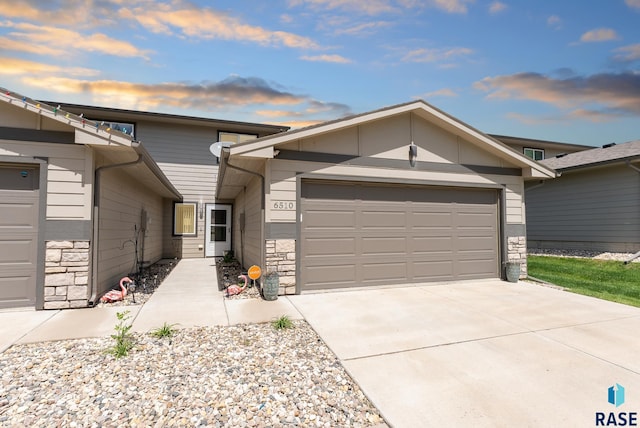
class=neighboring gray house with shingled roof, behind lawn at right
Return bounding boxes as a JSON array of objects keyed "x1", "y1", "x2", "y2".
[{"x1": 526, "y1": 140, "x2": 640, "y2": 252}]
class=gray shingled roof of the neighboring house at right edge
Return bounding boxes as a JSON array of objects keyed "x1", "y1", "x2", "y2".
[{"x1": 540, "y1": 140, "x2": 640, "y2": 171}]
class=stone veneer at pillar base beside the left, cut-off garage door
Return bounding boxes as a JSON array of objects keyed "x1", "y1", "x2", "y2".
[{"x1": 44, "y1": 241, "x2": 90, "y2": 309}]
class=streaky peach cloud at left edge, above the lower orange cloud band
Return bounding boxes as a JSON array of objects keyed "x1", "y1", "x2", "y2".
[{"x1": 0, "y1": 22, "x2": 151, "y2": 59}]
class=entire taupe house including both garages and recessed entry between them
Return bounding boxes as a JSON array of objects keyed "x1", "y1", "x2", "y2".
[{"x1": 0, "y1": 86, "x2": 556, "y2": 309}]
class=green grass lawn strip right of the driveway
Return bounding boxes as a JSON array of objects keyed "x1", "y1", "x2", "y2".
[{"x1": 528, "y1": 256, "x2": 640, "y2": 307}]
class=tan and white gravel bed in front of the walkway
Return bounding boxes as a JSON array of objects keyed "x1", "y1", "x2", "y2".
[{"x1": 0, "y1": 320, "x2": 384, "y2": 427}]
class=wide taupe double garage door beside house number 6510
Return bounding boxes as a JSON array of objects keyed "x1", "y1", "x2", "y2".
[{"x1": 300, "y1": 181, "x2": 498, "y2": 291}]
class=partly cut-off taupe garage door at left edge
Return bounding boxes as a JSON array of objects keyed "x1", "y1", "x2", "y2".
[{"x1": 0, "y1": 166, "x2": 39, "y2": 308}]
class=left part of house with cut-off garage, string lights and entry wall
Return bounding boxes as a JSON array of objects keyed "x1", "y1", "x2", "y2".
[{"x1": 0, "y1": 90, "x2": 286, "y2": 309}]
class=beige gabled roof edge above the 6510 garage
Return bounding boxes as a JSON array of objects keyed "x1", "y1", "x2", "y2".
[{"x1": 230, "y1": 100, "x2": 557, "y2": 178}]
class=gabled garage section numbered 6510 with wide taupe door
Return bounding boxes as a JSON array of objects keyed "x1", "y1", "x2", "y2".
[{"x1": 217, "y1": 101, "x2": 556, "y2": 294}]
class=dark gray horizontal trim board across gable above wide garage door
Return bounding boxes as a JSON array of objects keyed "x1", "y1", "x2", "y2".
[{"x1": 276, "y1": 150, "x2": 522, "y2": 177}]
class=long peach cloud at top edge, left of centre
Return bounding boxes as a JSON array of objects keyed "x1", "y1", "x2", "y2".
[{"x1": 118, "y1": 0, "x2": 319, "y2": 49}]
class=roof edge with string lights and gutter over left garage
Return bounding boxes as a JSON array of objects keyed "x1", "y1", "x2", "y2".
[{"x1": 0, "y1": 88, "x2": 182, "y2": 199}]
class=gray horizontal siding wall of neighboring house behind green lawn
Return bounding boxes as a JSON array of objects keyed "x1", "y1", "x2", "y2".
[{"x1": 526, "y1": 165, "x2": 640, "y2": 250}]
